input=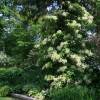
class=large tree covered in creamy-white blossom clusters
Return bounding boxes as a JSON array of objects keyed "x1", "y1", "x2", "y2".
[{"x1": 30, "y1": 1, "x2": 93, "y2": 87}]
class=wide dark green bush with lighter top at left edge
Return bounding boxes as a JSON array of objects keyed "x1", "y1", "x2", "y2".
[{"x1": 0, "y1": 67, "x2": 22, "y2": 85}]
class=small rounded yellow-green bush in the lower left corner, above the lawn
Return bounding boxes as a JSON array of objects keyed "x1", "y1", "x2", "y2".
[{"x1": 0, "y1": 85, "x2": 11, "y2": 97}]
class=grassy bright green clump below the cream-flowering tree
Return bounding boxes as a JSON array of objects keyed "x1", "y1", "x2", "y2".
[{"x1": 49, "y1": 86, "x2": 96, "y2": 100}]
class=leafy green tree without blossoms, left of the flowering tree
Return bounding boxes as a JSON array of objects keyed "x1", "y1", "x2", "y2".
[{"x1": 0, "y1": 0, "x2": 41, "y2": 64}]
